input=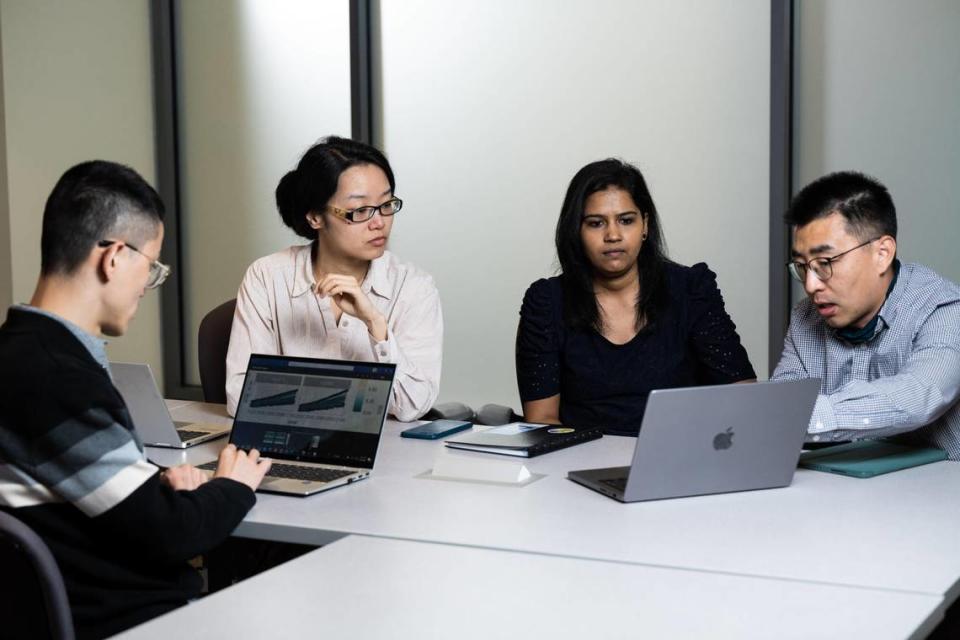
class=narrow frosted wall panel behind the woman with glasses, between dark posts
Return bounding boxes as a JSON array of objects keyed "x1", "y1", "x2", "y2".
[{"x1": 178, "y1": 0, "x2": 351, "y2": 384}]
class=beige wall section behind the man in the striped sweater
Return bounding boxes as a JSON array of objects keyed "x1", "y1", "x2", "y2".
[{"x1": 0, "y1": 0, "x2": 162, "y2": 379}]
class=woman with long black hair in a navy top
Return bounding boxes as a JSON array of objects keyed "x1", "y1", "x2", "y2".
[{"x1": 516, "y1": 159, "x2": 756, "y2": 435}]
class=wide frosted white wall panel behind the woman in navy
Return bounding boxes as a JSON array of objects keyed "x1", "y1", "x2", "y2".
[{"x1": 374, "y1": 0, "x2": 770, "y2": 407}]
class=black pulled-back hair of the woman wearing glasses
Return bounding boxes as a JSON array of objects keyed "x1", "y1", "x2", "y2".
[{"x1": 276, "y1": 136, "x2": 396, "y2": 240}]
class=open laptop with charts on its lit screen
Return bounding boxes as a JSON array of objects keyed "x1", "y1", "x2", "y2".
[{"x1": 199, "y1": 354, "x2": 396, "y2": 496}]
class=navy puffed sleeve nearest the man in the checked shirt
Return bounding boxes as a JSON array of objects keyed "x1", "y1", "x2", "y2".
[{"x1": 687, "y1": 262, "x2": 757, "y2": 384}]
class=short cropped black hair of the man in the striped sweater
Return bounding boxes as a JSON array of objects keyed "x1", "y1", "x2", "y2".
[{"x1": 40, "y1": 160, "x2": 164, "y2": 275}]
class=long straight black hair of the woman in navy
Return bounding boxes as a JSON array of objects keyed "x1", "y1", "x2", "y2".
[{"x1": 556, "y1": 158, "x2": 670, "y2": 331}]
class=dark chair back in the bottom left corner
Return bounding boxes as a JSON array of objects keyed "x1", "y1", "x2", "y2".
[{"x1": 0, "y1": 511, "x2": 74, "y2": 640}]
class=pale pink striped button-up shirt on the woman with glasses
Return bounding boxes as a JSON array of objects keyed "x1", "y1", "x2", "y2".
[{"x1": 226, "y1": 245, "x2": 443, "y2": 420}]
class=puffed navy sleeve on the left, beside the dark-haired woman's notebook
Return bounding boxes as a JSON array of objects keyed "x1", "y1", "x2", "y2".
[{"x1": 516, "y1": 279, "x2": 561, "y2": 402}]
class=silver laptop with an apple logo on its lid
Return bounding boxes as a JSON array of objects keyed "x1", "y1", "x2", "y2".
[{"x1": 567, "y1": 378, "x2": 820, "y2": 502}]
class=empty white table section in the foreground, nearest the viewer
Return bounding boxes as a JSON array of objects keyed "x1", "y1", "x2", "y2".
[{"x1": 118, "y1": 536, "x2": 940, "y2": 640}]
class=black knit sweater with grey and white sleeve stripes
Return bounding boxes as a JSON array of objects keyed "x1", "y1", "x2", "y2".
[{"x1": 0, "y1": 308, "x2": 255, "y2": 637}]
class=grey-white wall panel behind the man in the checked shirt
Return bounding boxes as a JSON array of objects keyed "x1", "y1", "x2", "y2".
[{"x1": 795, "y1": 0, "x2": 960, "y2": 284}]
